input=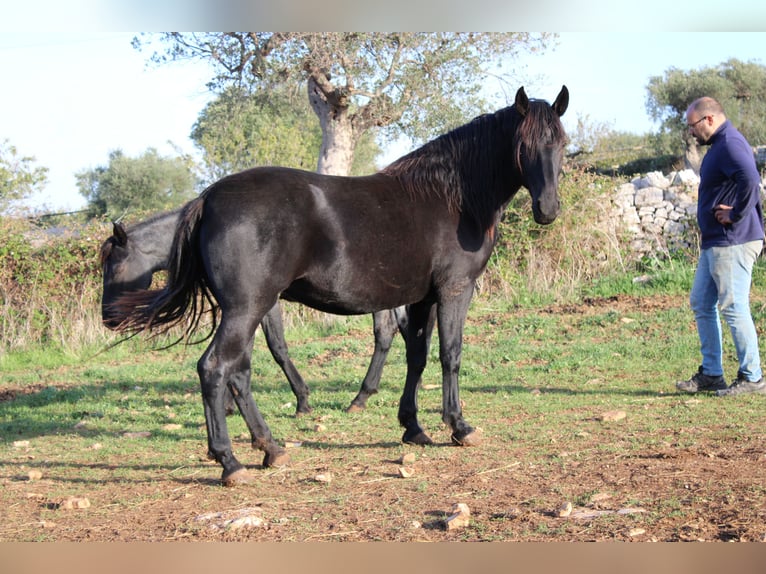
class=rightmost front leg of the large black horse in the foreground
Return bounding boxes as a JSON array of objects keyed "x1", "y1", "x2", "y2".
[{"x1": 438, "y1": 289, "x2": 481, "y2": 446}]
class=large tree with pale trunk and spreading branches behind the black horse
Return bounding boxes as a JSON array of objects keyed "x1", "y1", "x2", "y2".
[{"x1": 135, "y1": 32, "x2": 550, "y2": 175}]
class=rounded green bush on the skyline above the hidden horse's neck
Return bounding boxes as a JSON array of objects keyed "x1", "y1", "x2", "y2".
[{"x1": 76, "y1": 148, "x2": 195, "y2": 219}]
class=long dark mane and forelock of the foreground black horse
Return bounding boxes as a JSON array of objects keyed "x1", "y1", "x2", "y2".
[{"x1": 381, "y1": 100, "x2": 566, "y2": 229}]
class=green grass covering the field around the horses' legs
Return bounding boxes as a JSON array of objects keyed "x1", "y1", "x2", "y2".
[{"x1": 0, "y1": 258, "x2": 766, "y2": 540}]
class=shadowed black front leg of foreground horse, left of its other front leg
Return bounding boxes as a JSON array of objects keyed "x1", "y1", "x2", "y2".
[{"x1": 399, "y1": 303, "x2": 433, "y2": 445}]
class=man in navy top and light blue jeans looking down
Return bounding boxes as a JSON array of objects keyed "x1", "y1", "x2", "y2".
[{"x1": 676, "y1": 97, "x2": 766, "y2": 396}]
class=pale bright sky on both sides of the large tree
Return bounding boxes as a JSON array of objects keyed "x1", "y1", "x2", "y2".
[{"x1": 0, "y1": 31, "x2": 766, "y2": 212}]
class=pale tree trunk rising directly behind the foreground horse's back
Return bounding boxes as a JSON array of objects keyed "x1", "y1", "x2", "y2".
[{"x1": 308, "y1": 77, "x2": 356, "y2": 175}]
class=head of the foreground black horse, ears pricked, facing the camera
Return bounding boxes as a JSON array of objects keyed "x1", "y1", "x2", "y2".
[{"x1": 514, "y1": 86, "x2": 569, "y2": 225}]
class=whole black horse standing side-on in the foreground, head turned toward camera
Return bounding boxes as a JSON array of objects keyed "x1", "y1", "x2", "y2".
[{"x1": 116, "y1": 87, "x2": 569, "y2": 485}]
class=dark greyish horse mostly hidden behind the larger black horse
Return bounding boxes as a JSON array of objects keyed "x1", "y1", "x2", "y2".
[{"x1": 101, "y1": 209, "x2": 436, "y2": 415}]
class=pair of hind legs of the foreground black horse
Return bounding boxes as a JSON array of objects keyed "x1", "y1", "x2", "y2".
[{"x1": 197, "y1": 315, "x2": 287, "y2": 486}]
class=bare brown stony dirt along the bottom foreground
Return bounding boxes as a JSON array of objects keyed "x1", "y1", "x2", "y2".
[{"x1": 0, "y1": 298, "x2": 766, "y2": 542}]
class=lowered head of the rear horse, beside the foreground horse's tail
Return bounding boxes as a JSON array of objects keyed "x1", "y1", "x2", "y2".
[{"x1": 101, "y1": 223, "x2": 153, "y2": 329}]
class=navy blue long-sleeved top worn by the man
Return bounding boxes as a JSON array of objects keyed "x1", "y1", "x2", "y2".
[{"x1": 697, "y1": 120, "x2": 764, "y2": 249}]
